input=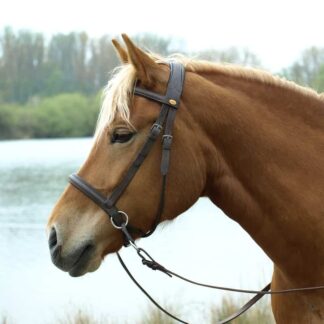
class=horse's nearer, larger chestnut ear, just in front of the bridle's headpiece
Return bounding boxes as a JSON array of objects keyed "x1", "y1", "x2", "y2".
[{"x1": 122, "y1": 34, "x2": 163, "y2": 87}]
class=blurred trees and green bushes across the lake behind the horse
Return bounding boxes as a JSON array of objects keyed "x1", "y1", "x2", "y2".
[{"x1": 0, "y1": 27, "x2": 324, "y2": 139}]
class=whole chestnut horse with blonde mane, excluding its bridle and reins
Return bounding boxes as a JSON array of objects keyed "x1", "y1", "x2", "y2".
[{"x1": 48, "y1": 34, "x2": 324, "y2": 324}]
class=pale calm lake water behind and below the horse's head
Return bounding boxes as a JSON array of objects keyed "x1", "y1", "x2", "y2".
[{"x1": 0, "y1": 139, "x2": 272, "y2": 324}]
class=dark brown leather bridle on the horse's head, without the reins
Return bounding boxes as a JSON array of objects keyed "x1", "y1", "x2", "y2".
[{"x1": 69, "y1": 62, "x2": 185, "y2": 245}]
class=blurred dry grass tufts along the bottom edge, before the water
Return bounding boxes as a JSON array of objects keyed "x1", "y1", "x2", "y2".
[{"x1": 0, "y1": 297, "x2": 275, "y2": 324}]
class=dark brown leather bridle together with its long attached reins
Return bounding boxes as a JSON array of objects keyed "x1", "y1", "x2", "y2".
[{"x1": 69, "y1": 62, "x2": 324, "y2": 324}]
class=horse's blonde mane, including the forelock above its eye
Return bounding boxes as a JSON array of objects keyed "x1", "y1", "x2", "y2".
[{"x1": 95, "y1": 54, "x2": 324, "y2": 138}]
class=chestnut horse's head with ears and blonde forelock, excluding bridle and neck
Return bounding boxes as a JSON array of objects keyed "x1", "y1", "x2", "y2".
[{"x1": 48, "y1": 35, "x2": 204, "y2": 276}]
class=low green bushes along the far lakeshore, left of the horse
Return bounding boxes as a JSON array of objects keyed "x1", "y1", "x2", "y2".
[{"x1": 0, "y1": 93, "x2": 100, "y2": 139}]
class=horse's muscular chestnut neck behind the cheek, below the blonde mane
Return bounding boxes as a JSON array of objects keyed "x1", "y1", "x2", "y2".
[{"x1": 188, "y1": 70, "x2": 324, "y2": 275}]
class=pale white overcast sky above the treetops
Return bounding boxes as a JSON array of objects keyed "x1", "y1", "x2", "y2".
[{"x1": 0, "y1": 0, "x2": 324, "y2": 71}]
